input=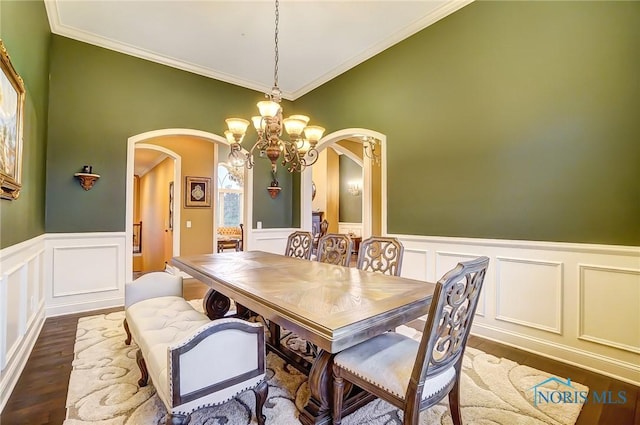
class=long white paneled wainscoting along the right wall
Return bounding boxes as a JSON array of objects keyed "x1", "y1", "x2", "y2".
[{"x1": 390, "y1": 235, "x2": 640, "y2": 390}]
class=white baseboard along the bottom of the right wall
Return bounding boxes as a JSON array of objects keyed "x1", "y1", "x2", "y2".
[{"x1": 472, "y1": 324, "x2": 640, "y2": 386}]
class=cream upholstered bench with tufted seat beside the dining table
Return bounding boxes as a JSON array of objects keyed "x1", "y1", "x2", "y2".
[{"x1": 124, "y1": 272, "x2": 268, "y2": 425}]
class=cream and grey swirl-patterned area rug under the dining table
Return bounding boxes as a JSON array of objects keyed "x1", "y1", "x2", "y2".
[{"x1": 64, "y1": 312, "x2": 588, "y2": 425}]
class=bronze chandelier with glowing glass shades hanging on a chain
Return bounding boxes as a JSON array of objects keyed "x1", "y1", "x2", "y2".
[{"x1": 224, "y1": 0, "x2": 324, "y2": 172}]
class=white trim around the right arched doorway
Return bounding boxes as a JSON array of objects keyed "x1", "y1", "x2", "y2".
[{"x1": 300, "y1": 128, "x2": 387, "y2": 239}]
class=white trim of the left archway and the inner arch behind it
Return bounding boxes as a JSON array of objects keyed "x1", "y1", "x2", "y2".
[{"x1": 125, "y1": 128, "x2": 253, "y2": 281}]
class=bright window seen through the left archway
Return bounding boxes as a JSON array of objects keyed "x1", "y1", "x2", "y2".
[{"x1": 216, "y1": 163, "x2": 244, "y2": 227}]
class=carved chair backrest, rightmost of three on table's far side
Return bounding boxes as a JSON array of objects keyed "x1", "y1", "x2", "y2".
[{"x1": 357, "y1": 236, "x2": 404, "y2": 276}]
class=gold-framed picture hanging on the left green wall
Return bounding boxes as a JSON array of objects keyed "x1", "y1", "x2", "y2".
[{"x1": 0, "y1": 40, "x2": 25, "y2": 200}]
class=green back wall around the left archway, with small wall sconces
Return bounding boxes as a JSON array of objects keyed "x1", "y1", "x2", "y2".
[{"x1": 46, "y1": 35, "x2": 291, "y2": 232}]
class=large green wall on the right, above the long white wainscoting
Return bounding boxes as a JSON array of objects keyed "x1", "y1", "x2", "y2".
[{"x1": 296, "y1": 1, "x2": 640, "y2": 246}]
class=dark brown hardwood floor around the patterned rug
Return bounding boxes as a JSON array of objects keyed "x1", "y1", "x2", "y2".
[{"x1": 0, "y1": 281, "x2": 640, "y2": 425}]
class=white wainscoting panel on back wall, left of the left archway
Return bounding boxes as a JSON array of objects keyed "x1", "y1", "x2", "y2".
[{"x1": 45, "y1": 232, "x2": 127, "y2": 317}]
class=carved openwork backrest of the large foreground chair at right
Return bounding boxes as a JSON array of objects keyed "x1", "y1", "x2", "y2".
[{"x1": 405, "y1": 257, "x2": 489, "y2": 405}]
